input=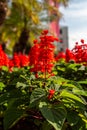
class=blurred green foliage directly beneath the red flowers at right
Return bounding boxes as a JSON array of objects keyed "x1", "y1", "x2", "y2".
[{"x1": 55, "y1": 61, "x2": 87, "y2": 89}]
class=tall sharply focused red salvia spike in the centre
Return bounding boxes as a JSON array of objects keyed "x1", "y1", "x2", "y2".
[{"x1": 39, "y1": 32, "x2": 57, "y2": 73}]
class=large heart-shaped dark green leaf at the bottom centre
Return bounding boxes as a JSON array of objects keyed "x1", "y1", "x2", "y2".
[{"x1": 39, "y1": 102, "x2": 67, "y2": 130}]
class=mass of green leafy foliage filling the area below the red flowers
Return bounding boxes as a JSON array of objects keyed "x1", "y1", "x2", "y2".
[{"x1": 0, "y1": 61, "x2": 87, "y2": 130}]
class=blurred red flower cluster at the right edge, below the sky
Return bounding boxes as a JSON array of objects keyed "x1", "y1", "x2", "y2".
[{"x1": 56, "y1": 39, "x2": 87, "y2": 65}]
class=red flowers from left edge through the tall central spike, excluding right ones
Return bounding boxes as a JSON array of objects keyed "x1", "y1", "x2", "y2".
[{"x1": 0, "y1": 30, "x2": 58, "y2": 75}]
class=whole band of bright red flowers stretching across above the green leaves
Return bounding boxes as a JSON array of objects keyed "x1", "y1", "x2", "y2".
[{"x1": 0, "y1": 30, "x2": 87, "y2": 73}]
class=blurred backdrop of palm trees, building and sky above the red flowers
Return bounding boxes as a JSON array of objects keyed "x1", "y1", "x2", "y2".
[{"x1": 0, "y1": 0, "x2": 87, "y2": 55}]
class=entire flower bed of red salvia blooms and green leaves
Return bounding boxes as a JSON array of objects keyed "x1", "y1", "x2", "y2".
[{"x1": 0, "y1": 30, "x2": 87, "y2": 130}]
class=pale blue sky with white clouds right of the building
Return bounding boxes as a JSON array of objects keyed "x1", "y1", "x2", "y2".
[{"x1": 59, "y1": 0, "x2": 87, "y2": 49}]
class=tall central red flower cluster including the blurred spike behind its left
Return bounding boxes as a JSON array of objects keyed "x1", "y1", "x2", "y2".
[{"x1": 29, "y1": 30, "x2": 58, "y2": 75}]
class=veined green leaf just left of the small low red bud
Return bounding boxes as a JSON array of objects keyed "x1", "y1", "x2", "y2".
[{"x1": 30, "y1": 88, "x2": 46, "y2": 105}]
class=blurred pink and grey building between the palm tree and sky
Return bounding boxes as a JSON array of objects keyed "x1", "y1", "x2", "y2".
[{"x1": 49, "y1": 0, "x2": 68, "y2": 52}]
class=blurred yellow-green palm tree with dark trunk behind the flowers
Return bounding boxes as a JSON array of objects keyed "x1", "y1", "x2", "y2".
[{"x1": 0, "y1": 0, "x2": 68, "y2": 53}]
